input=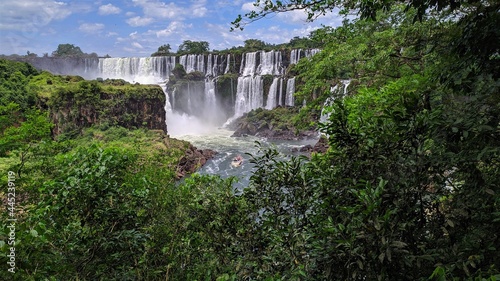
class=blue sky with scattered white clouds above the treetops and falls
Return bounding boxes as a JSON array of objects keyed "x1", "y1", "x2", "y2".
[{"x1": 0, "y1": 0, "x2": 342, "y2": 57}]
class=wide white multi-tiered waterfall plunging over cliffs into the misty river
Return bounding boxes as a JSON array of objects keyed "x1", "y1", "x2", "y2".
[{"x1": 26, "y1": 49, "x2": 319, "y2": 135}]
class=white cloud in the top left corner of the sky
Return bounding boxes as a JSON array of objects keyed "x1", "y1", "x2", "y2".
[{"x1": 0, "y1": 0, "x2": 73, "y2": 32}]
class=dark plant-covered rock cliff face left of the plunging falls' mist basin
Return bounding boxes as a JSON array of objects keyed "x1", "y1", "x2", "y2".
[{"x1": 48, "y1": 81, "x2": 167, "y2": 135}]
